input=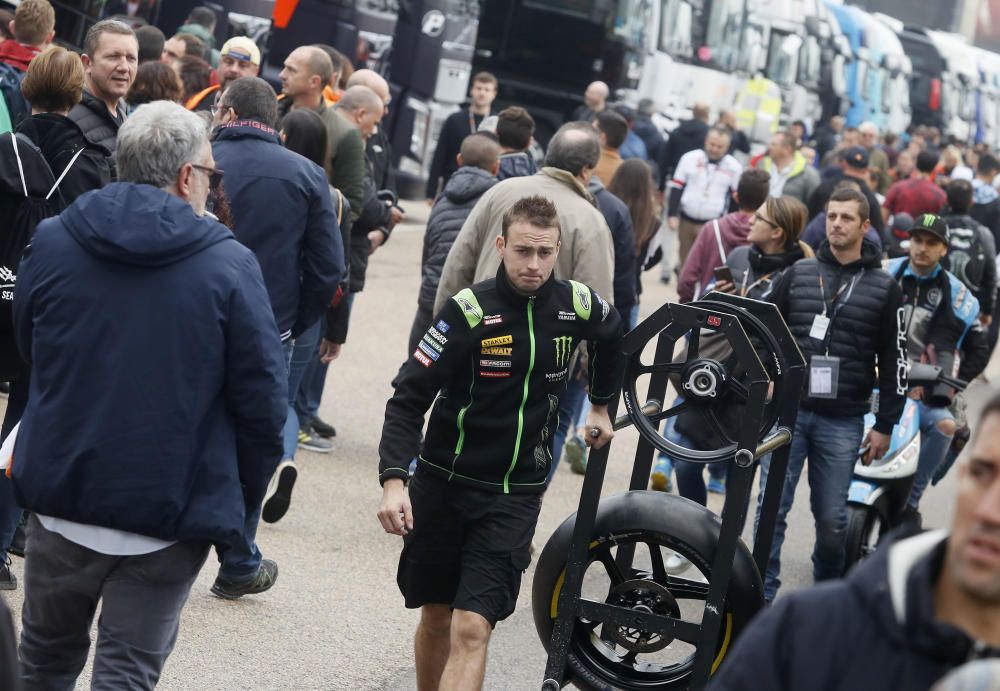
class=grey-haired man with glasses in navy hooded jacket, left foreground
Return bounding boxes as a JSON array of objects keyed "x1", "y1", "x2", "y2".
[{"x1": 12, "y1": 102, "x2": 287, "y2": 688}]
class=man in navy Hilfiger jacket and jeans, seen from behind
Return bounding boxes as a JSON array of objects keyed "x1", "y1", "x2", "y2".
[{"x1": 212, "y1": 77, "x2": 344, "y2": 556}]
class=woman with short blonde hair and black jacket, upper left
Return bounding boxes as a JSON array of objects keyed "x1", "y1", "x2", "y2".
[{"x1": 17, "y1": 46, "x2": 111, "y2": 204}]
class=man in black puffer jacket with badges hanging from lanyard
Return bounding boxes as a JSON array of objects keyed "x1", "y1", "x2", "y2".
[{"x1": 761, "y1": 188, "x2": 907, "y2": 604}]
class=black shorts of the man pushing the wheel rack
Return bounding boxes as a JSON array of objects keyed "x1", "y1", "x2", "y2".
[{"x1": 396, "y1": 469, "x2": 542, "y2": 626}]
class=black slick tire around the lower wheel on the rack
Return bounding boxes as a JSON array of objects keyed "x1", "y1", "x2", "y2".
[{"x1": 531, "y1": 491, "x2": 764, "y2": 691}]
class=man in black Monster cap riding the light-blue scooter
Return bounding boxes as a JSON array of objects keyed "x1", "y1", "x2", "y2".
[{"x1": 888, "y1": 214, "x2": 990, "y2": 525}]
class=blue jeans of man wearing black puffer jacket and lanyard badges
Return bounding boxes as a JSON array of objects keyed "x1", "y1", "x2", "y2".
[{"x1": 754, "y1": 409, "x2": 865, "y2": 602}]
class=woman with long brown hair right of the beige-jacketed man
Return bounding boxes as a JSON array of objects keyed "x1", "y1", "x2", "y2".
[{"x1": 608, "y1": 158, "x2": 660, "y2": 328}]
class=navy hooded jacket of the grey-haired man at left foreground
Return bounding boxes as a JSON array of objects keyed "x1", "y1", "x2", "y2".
[{"x1": 12, "y1": 183, "x2": 288, "y2": 544}]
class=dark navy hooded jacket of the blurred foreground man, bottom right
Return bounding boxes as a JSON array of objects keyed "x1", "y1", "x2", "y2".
[{"x1": 707, "y1": 531, "x2": 1000, "y2": 691}]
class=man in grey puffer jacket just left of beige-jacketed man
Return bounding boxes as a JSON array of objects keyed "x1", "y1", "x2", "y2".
[{"x1": 406, "y1": 134, "x2": 500, "y2": 353}]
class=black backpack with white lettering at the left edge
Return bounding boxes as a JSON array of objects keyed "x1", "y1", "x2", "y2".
[{"x1": 0, "y1": 132, "x2": 78, "y2": 378}]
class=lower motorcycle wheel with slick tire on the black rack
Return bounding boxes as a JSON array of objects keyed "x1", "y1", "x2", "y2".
[{"x1": 532, "y1": 492, "x2": 764, "y2": 691}]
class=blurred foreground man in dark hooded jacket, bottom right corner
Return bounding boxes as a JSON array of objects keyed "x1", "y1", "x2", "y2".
[{"x1": 708, "y1": 397, "x2": 1000, "y2": 691}]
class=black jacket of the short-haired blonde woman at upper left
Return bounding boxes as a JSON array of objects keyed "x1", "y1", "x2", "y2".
[{"x1": 17, "y1": 113, "x2": 111, "y2": 204}]
